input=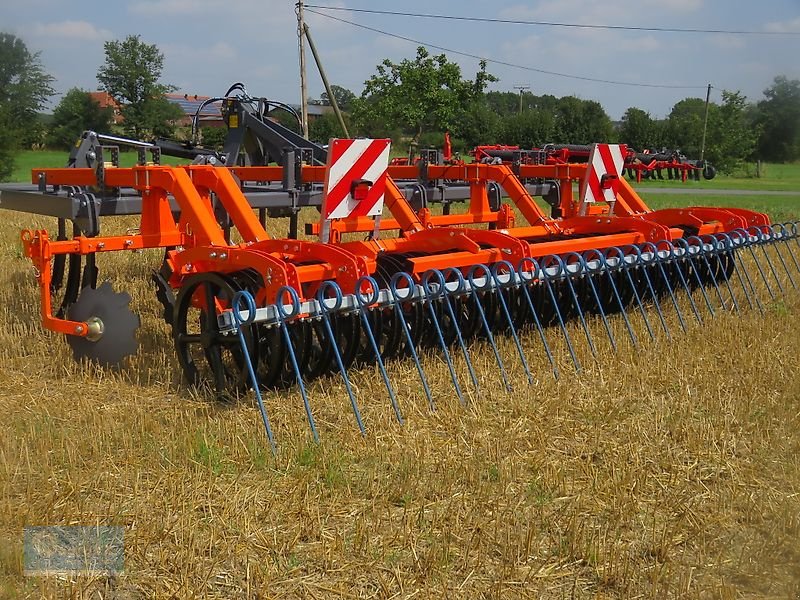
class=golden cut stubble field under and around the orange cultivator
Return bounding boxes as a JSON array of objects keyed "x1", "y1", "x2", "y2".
[{"x1": 0, "y1": 170, "x2": 800, "y2": 598}]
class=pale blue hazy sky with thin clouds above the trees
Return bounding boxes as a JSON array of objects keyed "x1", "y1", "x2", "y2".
[{"x1": 0, "y1": 0, "x2": 800, "y2": 119}]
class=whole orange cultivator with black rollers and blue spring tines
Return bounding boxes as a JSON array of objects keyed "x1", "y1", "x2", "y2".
[{"x1": 0, "y1": 127, "x2": 800, "y2": 450}]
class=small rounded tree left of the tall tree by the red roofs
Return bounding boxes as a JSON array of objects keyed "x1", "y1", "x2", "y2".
[{"x1": 47, "y1": 88, "x2": 114, "y2": 149}]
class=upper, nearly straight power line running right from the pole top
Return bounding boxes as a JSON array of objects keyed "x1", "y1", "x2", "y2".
[{"x1": 306, "y1": 4, "x2": 800, "y2": 35}]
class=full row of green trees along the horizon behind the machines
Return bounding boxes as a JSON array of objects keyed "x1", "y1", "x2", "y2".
[{"x1": 0, "y1": 33, "x2": 800, "y2": 180}]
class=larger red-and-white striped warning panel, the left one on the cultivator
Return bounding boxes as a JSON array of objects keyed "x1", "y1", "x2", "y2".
[{"x1": 322, "y1": 139, "x2": 391, "y2": 220}]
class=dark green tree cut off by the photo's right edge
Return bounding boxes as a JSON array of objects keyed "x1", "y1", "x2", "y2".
[{"x1": 756, "y1": 75, "x2": 800, "y2": 162}]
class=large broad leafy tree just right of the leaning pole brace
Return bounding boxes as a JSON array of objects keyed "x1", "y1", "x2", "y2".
[{"x1": 352, "y1": 47, "x2": 497, "y2": 139}]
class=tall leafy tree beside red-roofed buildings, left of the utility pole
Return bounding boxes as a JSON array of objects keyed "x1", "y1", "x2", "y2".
[{"x1": 97, "y1": 35, "x2": 183, "y2": 139}]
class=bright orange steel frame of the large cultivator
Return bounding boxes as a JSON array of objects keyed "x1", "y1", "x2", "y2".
[{"x1": 22, "y1": 163, "x2": 769, "y2": 336}]
